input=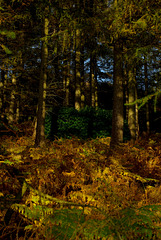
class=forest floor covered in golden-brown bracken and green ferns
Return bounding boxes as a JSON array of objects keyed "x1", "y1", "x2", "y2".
[{"x1": 0, "y1": 128, "x2": 161, "y2": 240}]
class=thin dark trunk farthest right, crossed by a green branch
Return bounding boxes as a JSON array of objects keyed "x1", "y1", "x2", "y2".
[{"x1": 144, "y1": 58, "x2": 150, "y2": 134}]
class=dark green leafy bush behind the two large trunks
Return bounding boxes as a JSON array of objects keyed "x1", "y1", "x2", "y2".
[{"x1": 45, "y1": 107, "x2": 130, "y2": 140}]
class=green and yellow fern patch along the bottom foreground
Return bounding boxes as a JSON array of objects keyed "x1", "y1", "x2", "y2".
[{"x1": 6, "y1": 181, "x2": 161, "y2": 240}]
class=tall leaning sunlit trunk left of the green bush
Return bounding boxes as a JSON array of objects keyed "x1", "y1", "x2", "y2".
[{"x1": 35, "y1": 17, "x2": 49, "y2": 146}]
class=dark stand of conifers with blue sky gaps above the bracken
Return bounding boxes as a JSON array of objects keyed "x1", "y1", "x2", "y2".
[{"x1": 0, "y1": 0, "x2": 161, "y2": 146}]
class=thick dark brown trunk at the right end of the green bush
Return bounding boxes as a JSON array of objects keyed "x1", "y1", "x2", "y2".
[{"x1": 110, "y1": 40, "x2": 124, "y2": 148}]
